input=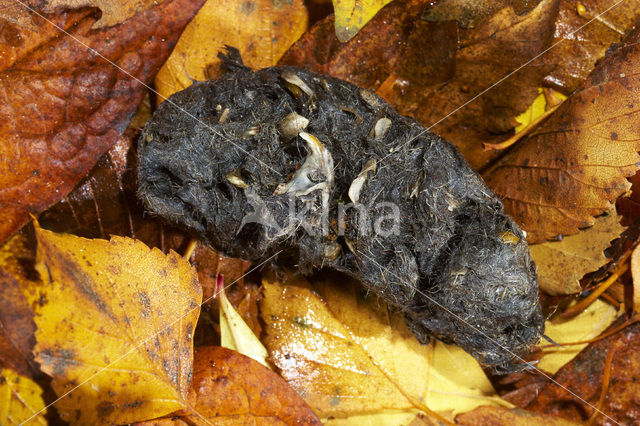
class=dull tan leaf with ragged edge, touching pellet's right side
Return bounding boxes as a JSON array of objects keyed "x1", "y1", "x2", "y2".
[{"x1": 529, "y1": 210, "x2": 625, "y2": 296}]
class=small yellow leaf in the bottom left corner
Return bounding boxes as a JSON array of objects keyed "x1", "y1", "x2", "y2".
[{"x1": 0, "y1": 369, "x2": 47, "y2": 426}]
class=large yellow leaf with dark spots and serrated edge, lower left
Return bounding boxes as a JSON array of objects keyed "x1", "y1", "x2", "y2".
[{"x1": 34, "y1": 226, "x2": 202, "y2": 424}]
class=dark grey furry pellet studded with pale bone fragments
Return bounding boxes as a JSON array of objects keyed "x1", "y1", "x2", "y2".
[{"x1": 138, "y1": 51, "x2": 544, "y2": 371}]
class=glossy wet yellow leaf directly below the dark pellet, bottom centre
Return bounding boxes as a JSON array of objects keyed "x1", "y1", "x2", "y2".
[{"x1": 261, "y1": 275, "x2": 500, "y2": 420}]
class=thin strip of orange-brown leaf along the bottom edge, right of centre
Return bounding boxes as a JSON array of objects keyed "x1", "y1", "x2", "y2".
[{"x1": 456, "y1": 406, "x2": 578, "y2": 426}]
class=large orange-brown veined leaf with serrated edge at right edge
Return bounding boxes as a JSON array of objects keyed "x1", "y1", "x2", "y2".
[{"x1": 484, "y1": 23, "x2": 640, "y2": 242}]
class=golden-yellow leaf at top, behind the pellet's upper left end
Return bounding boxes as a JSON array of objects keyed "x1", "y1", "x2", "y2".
[{"x1": 156, "y1": 0, "x2": 308, "y2": 100}]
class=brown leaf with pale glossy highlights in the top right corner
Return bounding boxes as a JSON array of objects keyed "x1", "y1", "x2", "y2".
[{"x1": 543, "y1": 0, "x2": 640, "y2": 94}]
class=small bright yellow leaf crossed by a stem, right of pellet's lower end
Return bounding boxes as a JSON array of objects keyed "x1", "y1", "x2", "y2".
[{"x1": 537, "y1": 299, "x2": 618, "y2": 375}]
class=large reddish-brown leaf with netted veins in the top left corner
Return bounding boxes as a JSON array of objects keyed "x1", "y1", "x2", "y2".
[{"x1": 0, "y1": 0, "x2": 202, "y2": 246}]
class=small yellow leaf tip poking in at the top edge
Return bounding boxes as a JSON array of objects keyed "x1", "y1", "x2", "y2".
[{"x1": 333, "y1": 0, "x2": 393, "y2": 43}]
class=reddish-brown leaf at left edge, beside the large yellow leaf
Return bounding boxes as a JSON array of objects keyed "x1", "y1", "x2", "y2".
[{"x1": 0, "y1": 234, "x2": 38, "y2": 378}]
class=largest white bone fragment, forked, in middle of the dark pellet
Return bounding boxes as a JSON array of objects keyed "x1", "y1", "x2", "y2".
[{"x1": 273, "y1": 132, "x2": 333, "y2": 196}]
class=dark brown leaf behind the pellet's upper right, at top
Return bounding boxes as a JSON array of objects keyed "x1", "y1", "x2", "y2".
[{"x1": 281, "y1": 0, "x2": 558, "y2": 169}]
